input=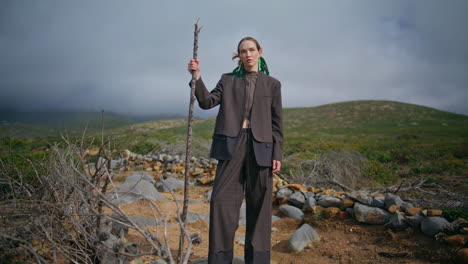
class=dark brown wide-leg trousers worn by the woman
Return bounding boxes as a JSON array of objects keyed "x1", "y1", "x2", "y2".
[{"x1": 208, "y1": 128, "x2": 272, "y2": 264}]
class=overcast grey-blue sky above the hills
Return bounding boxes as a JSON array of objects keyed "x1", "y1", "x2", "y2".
[{"x1": 0, "y1": 0, "x2": 468, "y2": 116}]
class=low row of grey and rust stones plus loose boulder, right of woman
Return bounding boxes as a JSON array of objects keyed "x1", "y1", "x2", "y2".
[{"x1": 274, "y1": 183, "x2": 468, "y2": 255}]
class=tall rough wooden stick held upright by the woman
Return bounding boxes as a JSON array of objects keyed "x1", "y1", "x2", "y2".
[{"x1": 178, "y1": 19, "x2": 201, "y2": 263}]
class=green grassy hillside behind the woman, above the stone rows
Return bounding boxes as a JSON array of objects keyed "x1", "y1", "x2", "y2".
[{"x1": 1, "y1": 101, "x2": 468, "y2": 190}]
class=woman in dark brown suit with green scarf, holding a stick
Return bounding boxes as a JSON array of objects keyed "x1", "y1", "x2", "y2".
[{"x1": 188, "y1": 37, "x2": 283, "y2": 264}]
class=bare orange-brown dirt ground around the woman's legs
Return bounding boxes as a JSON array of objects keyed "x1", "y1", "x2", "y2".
[{"x1": 113, "y1": 172, "x2": 456, "y2": 264}]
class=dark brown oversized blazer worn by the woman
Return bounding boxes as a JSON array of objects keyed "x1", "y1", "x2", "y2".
[{"x1": 195, "y1": 72, "x2": 283, "y2": 167}]
